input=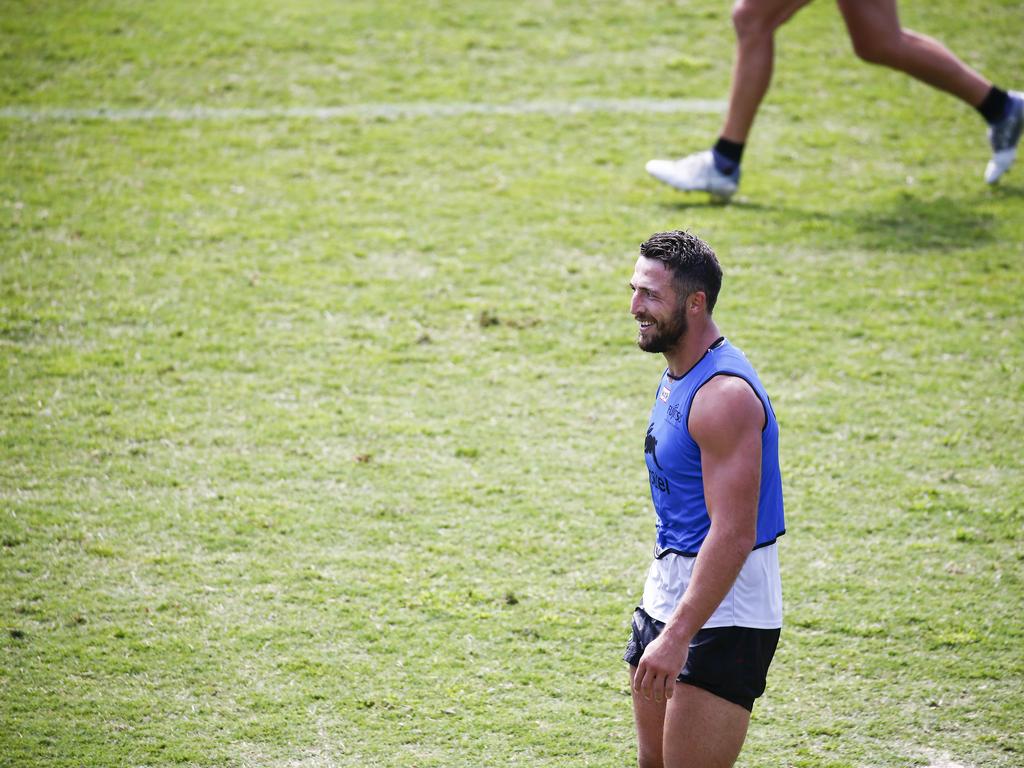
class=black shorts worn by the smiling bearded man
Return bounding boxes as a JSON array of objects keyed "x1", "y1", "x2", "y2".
[{"x1": 623, "y1": 608, "x2": 781, "y2": 711}]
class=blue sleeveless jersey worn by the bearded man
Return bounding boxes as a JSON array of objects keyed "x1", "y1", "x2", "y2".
[{"x1": 644, "y1": 339, "x2": 785, "y2": 557}]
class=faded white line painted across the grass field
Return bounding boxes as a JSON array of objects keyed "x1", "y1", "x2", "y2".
[{"x1": 0, "y1": 98, "x2": 726, "y2": 122}]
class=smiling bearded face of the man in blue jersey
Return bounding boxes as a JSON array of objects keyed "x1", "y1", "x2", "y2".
[{"x1": 630, "y1": 256, "x2": 686, "y2": 352}]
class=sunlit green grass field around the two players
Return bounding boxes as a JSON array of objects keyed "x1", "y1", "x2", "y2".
[{"x1": 0, "y1": 0, "x2": 1024, "y2": 768}]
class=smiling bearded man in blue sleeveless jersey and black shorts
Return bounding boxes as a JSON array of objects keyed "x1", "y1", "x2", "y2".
[{"x1": 625, "y1": 231, "x2": 785, "y2": 768}]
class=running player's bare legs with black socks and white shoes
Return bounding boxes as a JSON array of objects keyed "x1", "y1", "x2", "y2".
[{"x1": 647, "y1": 0, "x2": 1024, "y2": 200}]
